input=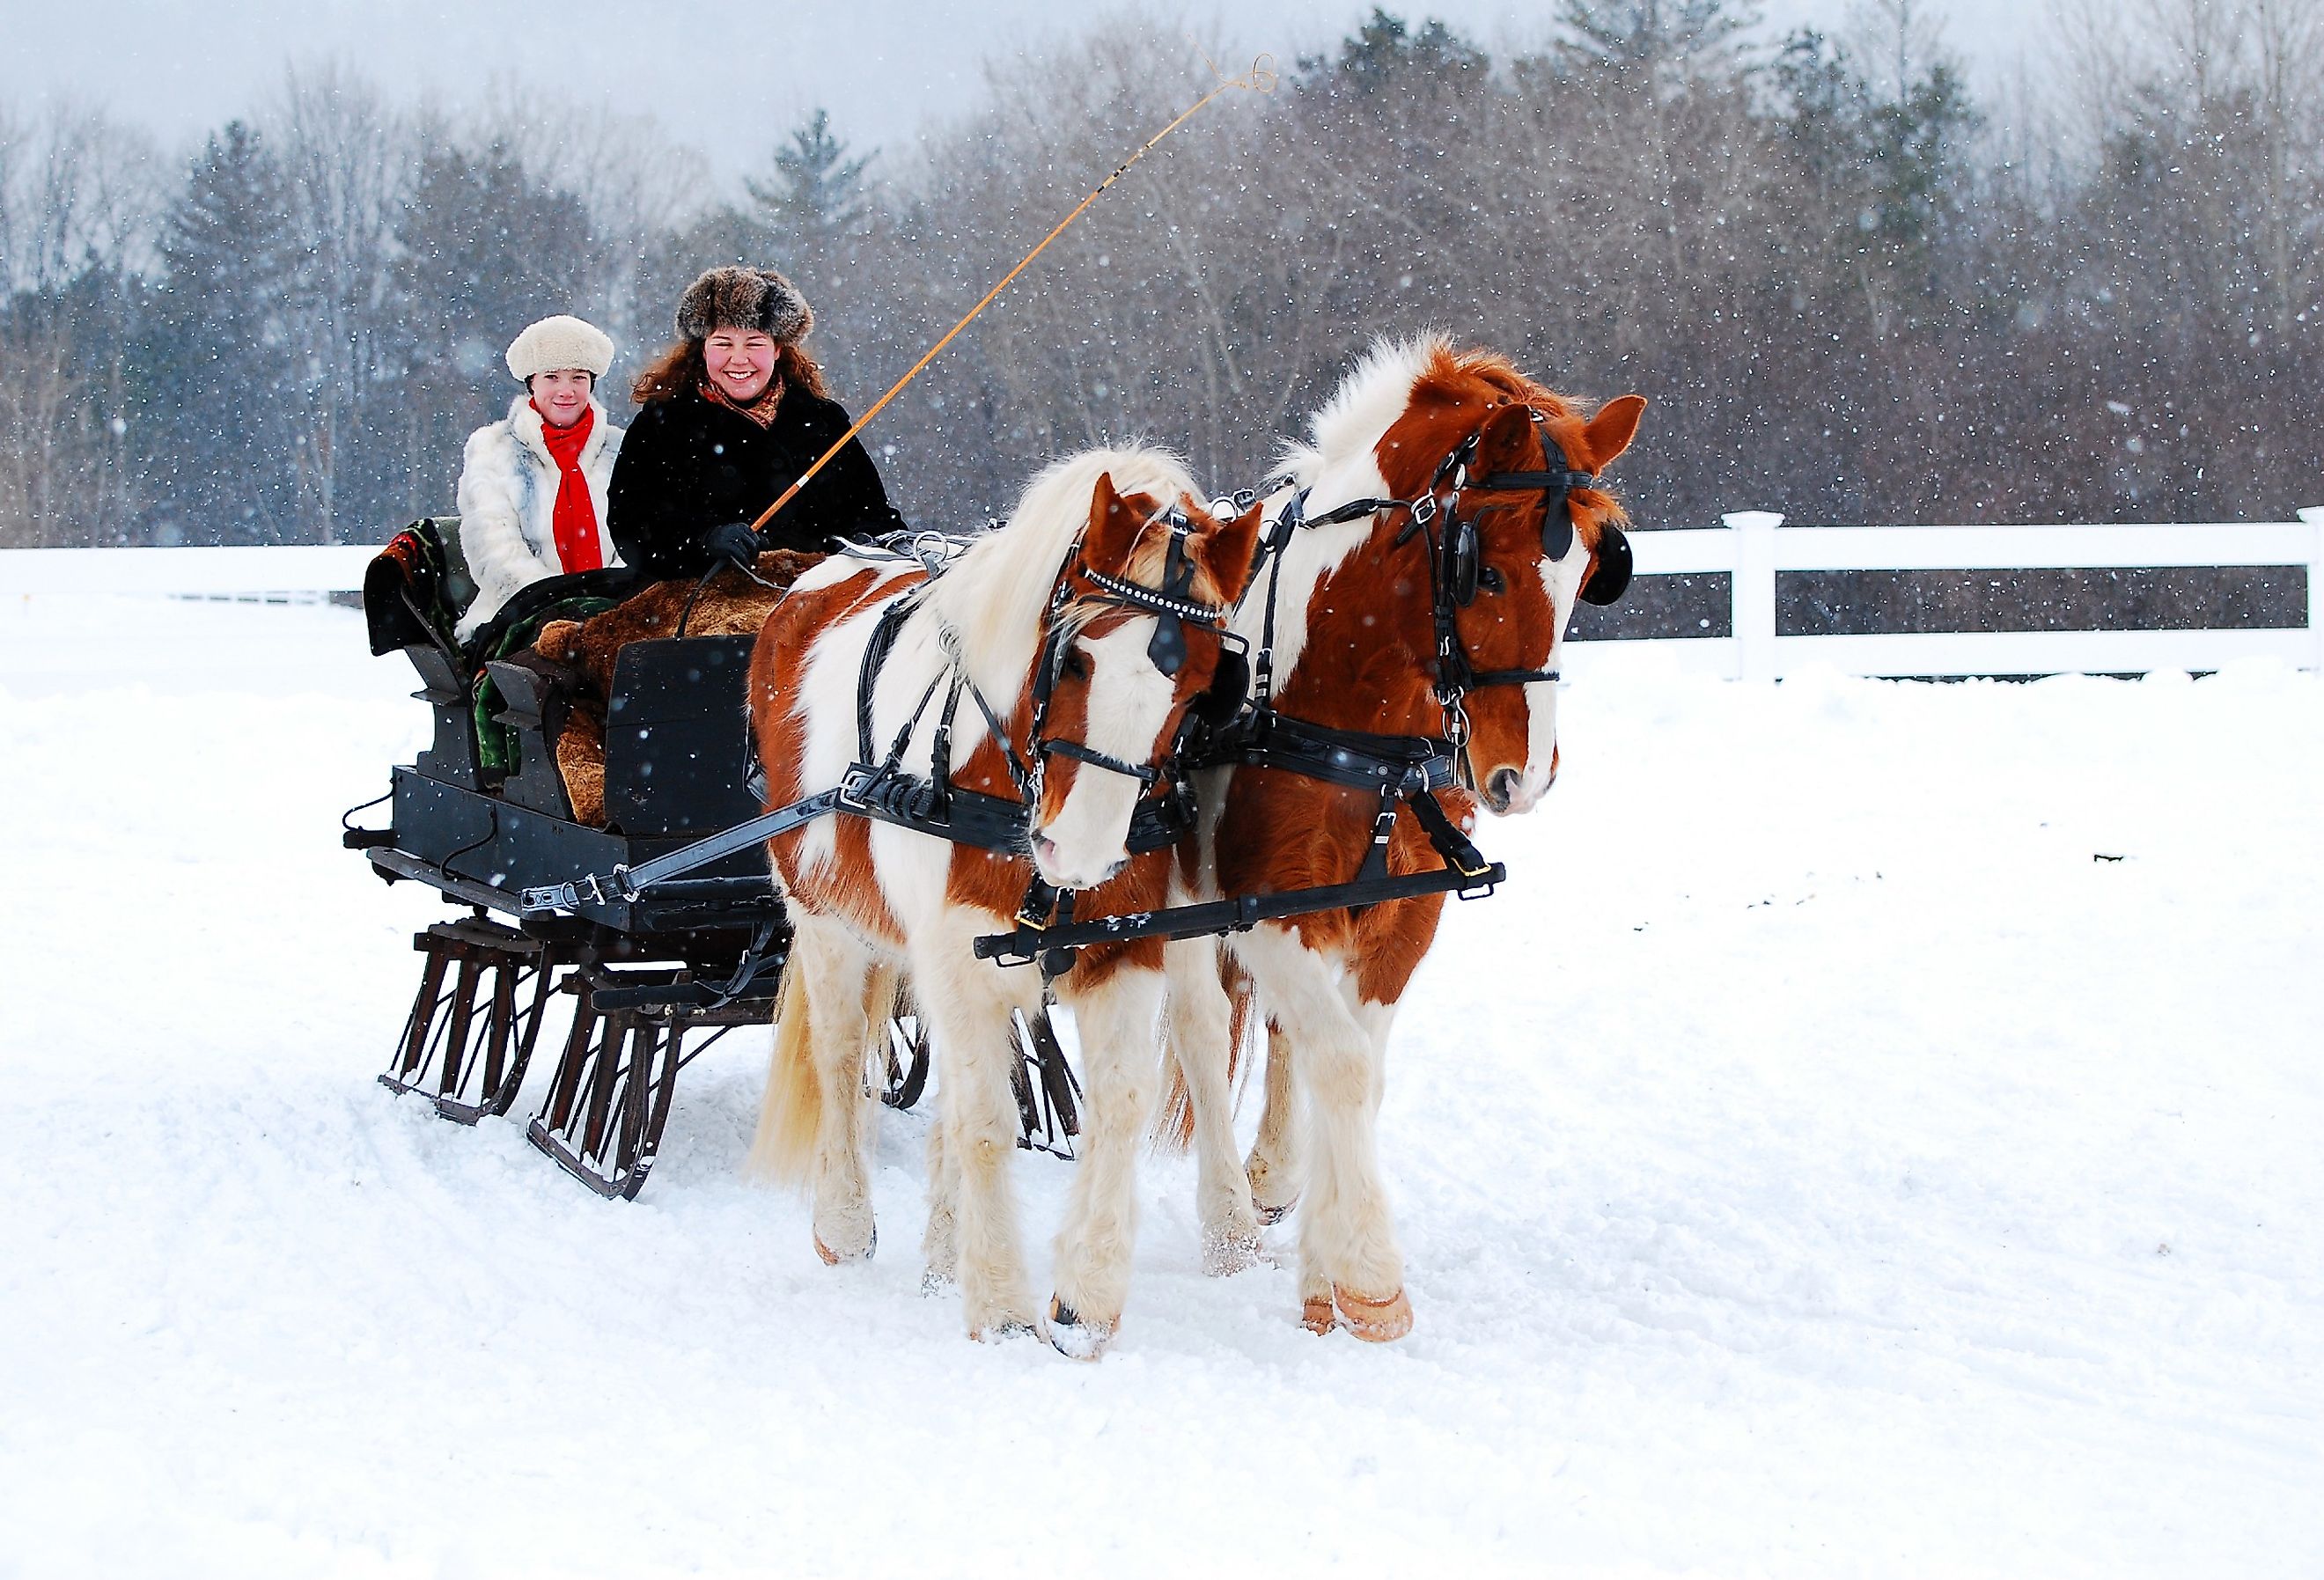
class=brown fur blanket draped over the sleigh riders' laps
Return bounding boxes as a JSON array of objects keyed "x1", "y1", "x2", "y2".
[{"x1": 533, "y1": 548, "x2": 823, "y2": 827}]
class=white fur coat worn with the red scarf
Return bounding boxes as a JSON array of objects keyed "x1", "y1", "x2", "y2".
[{"x1": 458, "y1": 395, "x2": 623, "y2": 642}]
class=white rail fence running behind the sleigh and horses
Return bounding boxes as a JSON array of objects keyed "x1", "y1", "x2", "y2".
[{"x1": 0, "y1": 506, "x2": 2324, "y2": 680}]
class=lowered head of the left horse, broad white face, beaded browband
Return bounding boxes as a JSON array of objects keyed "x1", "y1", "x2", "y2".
[{"x1": 1030, "y1": 472, "x2": 1260, "y2": 887}]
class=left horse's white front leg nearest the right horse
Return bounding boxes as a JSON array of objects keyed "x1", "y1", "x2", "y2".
[{"x1": 1048, "y1": 964, "x2": 1171, "y2": 1362}]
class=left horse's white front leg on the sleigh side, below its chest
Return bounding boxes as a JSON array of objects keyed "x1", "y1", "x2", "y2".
[{"x1": 911, "y1": 934, "x2": 1034, "y2": 1338}]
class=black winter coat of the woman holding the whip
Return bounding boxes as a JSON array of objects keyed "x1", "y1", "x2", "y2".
[{"x1": 607, "y1": 386, "x2": 904, "y2": 581}]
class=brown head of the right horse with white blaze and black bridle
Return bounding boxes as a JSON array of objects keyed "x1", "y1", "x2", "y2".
[{"x1": 1376, "y1": 346, "x2": 1645, "y2": 816}]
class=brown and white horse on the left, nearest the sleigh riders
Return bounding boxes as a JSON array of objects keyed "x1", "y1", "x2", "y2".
[{"x1": 751, "y1": 448, "x2": 1260, "y2": 1355}]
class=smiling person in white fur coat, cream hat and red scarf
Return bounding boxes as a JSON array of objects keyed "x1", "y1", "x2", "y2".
[{"x1": 455, "y1": 313, "x2": 623, "y2": 642}]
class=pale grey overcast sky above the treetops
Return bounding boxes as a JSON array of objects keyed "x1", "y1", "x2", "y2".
[{"x1": 0, "y1": 0, "x2": 2045, "y2": 174}]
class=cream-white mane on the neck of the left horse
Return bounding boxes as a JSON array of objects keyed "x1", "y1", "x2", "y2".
[{"x1": 927, "y1": 444, "x2": 1216, "y2": 697}]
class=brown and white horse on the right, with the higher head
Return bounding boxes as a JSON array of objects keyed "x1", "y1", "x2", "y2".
[{"x1": 1169, "y1": 339, "x2": 1645, "y2": 1341}]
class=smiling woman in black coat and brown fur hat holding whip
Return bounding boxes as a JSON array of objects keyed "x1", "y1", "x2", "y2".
[{"x1": 607, "y1": 269, "x2": 904, "y2": 581}]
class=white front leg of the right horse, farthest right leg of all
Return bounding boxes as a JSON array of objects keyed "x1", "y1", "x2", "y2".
[{"x1": 1236, "y1": 927, "x2": 1413, "y2": 1341}]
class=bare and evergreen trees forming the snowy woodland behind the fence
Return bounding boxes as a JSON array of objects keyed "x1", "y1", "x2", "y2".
[{"x1": 0, "y1": 0, "x2": 2324, "y2": 622}]
